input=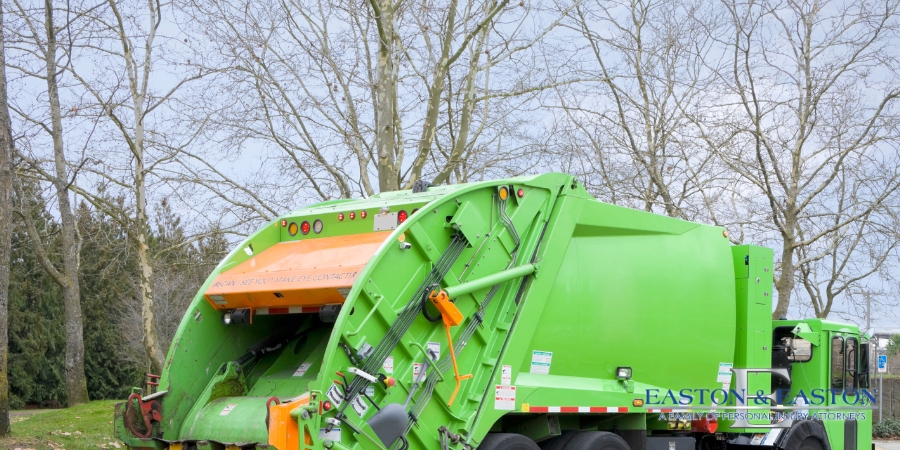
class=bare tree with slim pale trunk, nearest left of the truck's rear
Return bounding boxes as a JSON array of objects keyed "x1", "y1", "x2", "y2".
[{"x1": 58, "y1": 0, "x2": 209, "y2": 371}]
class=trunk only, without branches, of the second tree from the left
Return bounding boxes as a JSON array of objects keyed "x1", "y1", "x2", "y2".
[{"x1": 44, "y1": 0, "x2": 88, "y2": 406}]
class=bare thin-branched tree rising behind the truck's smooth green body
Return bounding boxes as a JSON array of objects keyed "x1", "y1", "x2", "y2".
[{"x1": 552, "y1": 0, "x2": 723, "y2": 220}]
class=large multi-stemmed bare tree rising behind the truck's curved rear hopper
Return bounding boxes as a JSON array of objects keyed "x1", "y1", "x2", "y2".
[{"x1": 180, "y1": 0, "x2": 558, "y2": 219}]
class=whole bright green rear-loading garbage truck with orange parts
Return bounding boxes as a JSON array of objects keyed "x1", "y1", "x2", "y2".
[{"x1": 114, "y1": 173, "x2": 873, "y2": 450}]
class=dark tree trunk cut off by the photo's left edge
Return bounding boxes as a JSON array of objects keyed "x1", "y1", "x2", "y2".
[{"x1": 0, "y1": 3, "x2": 13, "y2": 436}]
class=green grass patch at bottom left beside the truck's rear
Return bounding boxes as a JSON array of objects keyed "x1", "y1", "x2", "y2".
[{"x1": 0, "y1": 400, "x2": 125, "y2": 450}]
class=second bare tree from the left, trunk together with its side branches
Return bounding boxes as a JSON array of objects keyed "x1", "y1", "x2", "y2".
[{"x1": 5, "y1": 0, "x2": 88, "y2": 406}]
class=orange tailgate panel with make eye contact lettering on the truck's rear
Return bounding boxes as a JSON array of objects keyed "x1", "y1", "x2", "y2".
[{"x1": 204, "y1": 231, "x2": 391, "y2": 309}]
